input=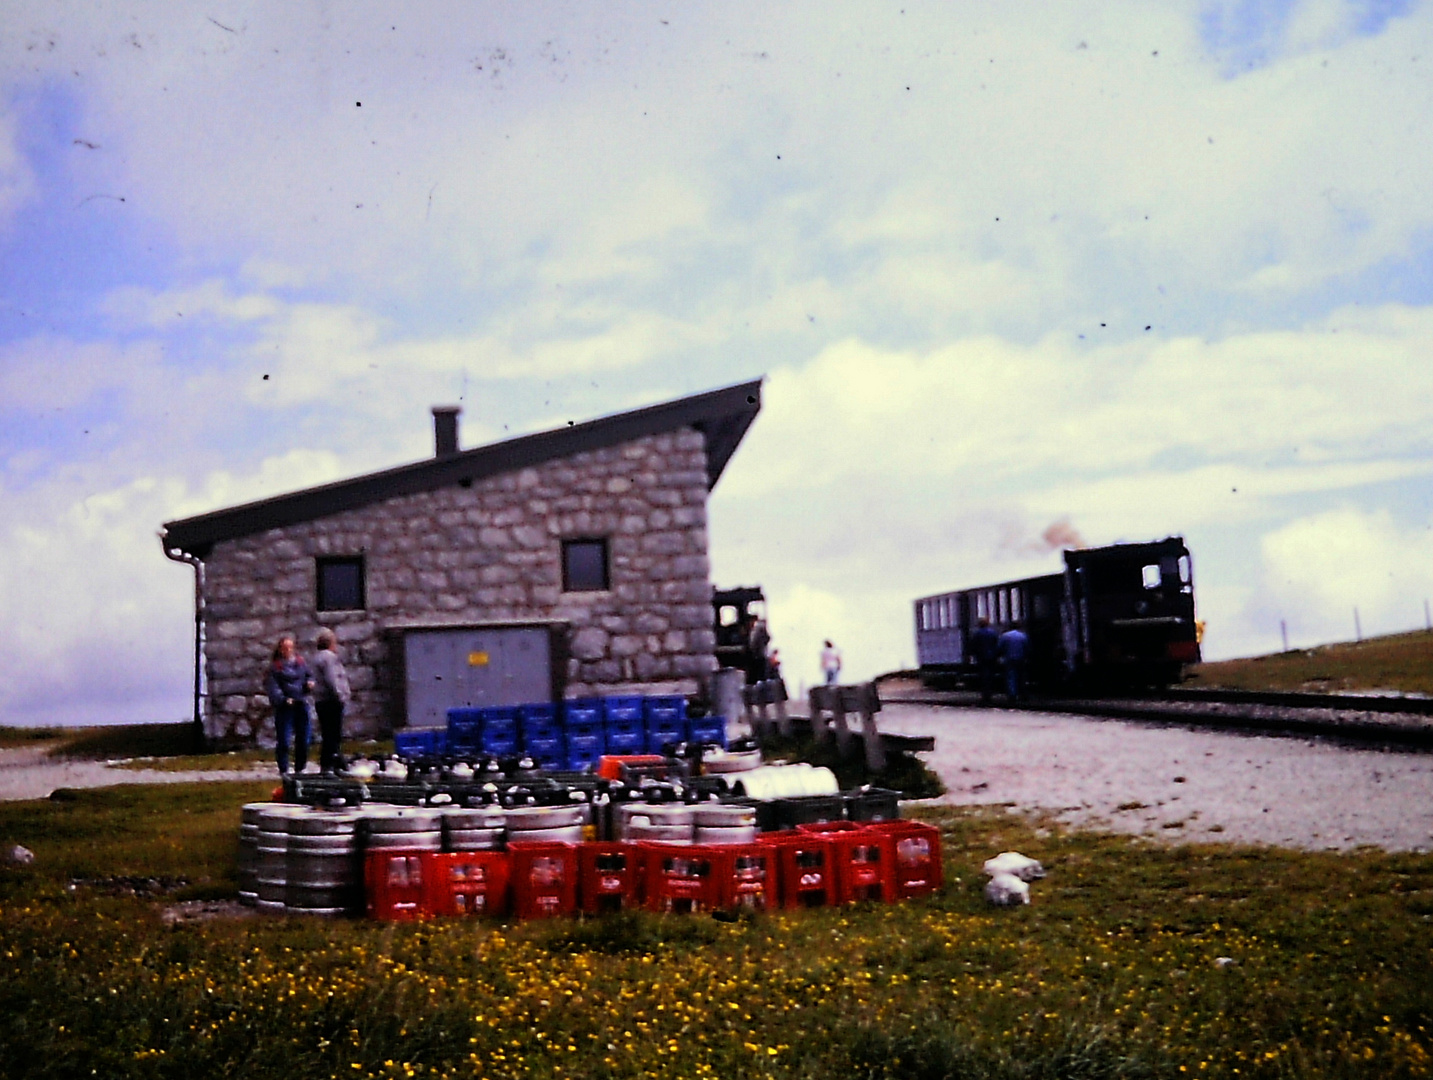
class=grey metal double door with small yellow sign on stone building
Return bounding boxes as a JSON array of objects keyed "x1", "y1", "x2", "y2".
[{"x1": 403, "y1": 626, "x2": 553, "y2": 728}]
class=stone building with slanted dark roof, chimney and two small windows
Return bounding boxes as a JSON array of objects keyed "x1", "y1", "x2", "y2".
[{"x1": 160, "y1": 381, "x2": 761, "y2": 739}]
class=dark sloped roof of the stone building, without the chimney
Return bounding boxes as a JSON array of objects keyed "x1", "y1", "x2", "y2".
[{"x1": 159, "y1": 380, "x2": 761, "y2": 559}]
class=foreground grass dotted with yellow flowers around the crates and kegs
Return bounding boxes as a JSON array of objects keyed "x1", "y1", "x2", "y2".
[{"x1": 0, "y1": 784, "x2": 1433, "y2": 1080}]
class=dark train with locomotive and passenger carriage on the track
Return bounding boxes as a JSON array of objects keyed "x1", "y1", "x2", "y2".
[{"x1": 916, "y1": 536, "x2": 1199, "y2": 692}]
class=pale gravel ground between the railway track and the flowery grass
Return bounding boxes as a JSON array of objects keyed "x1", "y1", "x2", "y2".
[{"x1": 880, "y1": 703, "x2": 1433, "y2": 851}]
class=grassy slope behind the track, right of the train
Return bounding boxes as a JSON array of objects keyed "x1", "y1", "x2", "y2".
[{"x1": 1184, "y1": 630, "x2": 1433, "y2": 696}]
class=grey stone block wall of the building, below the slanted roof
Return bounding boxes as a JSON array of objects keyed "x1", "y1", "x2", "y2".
[{"x1": 205, "y1": 430, "x2": 717, "y2": 739}]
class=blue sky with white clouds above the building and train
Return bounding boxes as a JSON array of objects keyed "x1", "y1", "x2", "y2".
[{"x1": 0, "y1": 0, "x2": 1433, "y2": 723}]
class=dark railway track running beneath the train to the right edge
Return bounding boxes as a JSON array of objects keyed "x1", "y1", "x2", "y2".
[{"x1": 877, "y1": 672, "x2": 1433, "y2": 749}]
